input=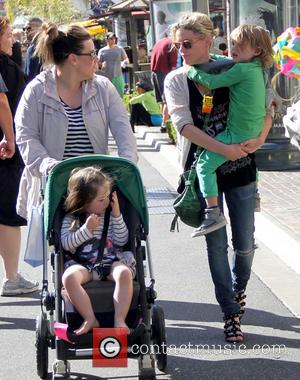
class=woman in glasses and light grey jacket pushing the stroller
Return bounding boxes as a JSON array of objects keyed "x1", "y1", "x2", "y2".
[{"x1": 15, "y1": 23, "x2": 137, "y2": 223}]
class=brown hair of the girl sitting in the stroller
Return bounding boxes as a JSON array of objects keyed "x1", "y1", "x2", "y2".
[{"x1": 65, "y1": 166, "x2": 113, "y2": 215}]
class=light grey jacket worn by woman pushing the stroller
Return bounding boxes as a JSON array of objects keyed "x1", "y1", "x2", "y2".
[{"x1": 15, "y1": 68, "x2": 138, "y2": 218}]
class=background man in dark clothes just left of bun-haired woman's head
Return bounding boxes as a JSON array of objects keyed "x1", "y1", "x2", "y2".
[{"x1": 23, "y1": 17, "x2": 43, "y2": 83}]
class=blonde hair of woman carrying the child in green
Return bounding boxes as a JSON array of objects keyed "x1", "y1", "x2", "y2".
[{"x1": 171, "y1": 12, "x2": 215, "y2": 40}]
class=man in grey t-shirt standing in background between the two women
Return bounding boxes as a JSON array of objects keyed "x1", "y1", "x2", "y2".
[{"x1": 98, "y1": 32, "x2": 129, "y2": 97}]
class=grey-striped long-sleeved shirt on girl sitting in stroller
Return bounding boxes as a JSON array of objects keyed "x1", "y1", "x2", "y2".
[{"x1": 61, "y1": 214, "x2": 128, "y2": 255}]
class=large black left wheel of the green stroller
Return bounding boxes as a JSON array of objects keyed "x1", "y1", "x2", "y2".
[{"x1": 35, "y1": 312, "x2": 48, "y2": 379}]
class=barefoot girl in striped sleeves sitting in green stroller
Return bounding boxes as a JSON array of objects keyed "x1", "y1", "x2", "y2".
[{"x1": 61, "y1": 167, "x2": 136, "y2": 335}]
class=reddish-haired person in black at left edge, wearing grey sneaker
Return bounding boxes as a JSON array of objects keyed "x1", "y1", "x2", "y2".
[{"x1": 0, "y1": 16, "x2": 38, "y2": 296}]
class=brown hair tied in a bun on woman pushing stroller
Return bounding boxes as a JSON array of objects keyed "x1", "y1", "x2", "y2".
[{"x1": 35, "y1": 22, "x2": 91, "y2": 66}]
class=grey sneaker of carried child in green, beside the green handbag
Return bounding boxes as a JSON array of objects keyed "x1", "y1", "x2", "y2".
[{"x1": 191, "y1": 207, "x2": 227, "y2": 237}]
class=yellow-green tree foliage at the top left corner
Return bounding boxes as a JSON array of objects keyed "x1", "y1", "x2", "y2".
[{"x1": 5, "y1": 0, "x2": 88, "y2": 25}]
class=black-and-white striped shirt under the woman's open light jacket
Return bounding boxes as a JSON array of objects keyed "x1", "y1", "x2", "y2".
[{"x1": 61, "y1": 100, "x2": 94, "y2": 160}]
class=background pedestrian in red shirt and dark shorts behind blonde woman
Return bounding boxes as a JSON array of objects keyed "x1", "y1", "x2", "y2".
[{"x1": 151, "y1": 37, "x2": 177, "y2": 132}]
